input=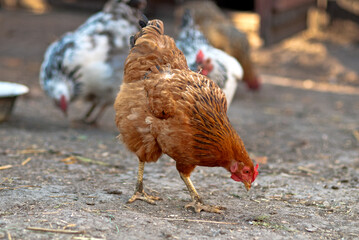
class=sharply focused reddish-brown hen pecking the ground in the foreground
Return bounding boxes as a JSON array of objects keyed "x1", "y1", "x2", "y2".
[{"x1": 114, "y1": 20, "x2": 258, "y2": 213}]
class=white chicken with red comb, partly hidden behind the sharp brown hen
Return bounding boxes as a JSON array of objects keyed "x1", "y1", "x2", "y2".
[{"x1": 176, "y1": 9, "x2": 243, "y2": 106}]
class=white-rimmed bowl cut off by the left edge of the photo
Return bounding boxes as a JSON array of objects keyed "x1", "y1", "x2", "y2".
[{"x1": 0, "y1": 82, "x2": 29, "y2": 122}]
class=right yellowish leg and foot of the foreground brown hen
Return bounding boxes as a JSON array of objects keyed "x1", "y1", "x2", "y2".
[{"x1": 180, "y1": 173, "x2": 225, "y2": 213}]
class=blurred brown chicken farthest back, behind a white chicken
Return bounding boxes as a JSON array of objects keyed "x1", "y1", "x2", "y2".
[{"x1": 176, "y1": 0, "x2": 261, "y2": 90}]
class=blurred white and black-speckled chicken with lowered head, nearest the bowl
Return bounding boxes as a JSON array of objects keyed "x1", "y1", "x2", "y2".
[{"x1": 40, "y1": 0, "x2": 146, "y2": 124}]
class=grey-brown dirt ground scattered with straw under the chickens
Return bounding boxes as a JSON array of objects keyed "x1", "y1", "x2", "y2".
[{"x1": 0, "y1": 6, "x2": 359, "y2": 239}]
